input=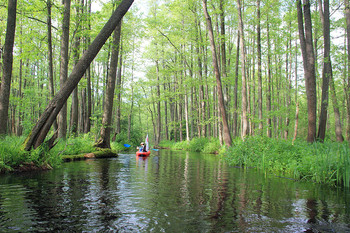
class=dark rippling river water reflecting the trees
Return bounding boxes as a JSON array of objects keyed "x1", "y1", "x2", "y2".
[{"x1": 0, "y1": 151, "x2": 350, "y2": 232}]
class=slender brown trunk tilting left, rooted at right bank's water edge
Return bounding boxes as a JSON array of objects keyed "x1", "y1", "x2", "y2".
[{"x1": 202, "y1": 0, "x2": 232, "y2": 147}]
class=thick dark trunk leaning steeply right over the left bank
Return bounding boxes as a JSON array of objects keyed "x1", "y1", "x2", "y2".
[{"x1": 24, "y1": 0, "x2": 134, "y2": 150}]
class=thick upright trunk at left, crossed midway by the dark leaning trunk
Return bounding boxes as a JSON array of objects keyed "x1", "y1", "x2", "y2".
[{"x1": 58, "y1": 0, "x2": 71, "y2": 139}]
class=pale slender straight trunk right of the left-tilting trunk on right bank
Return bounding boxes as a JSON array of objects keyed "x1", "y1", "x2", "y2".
[{"x1": 237, "y1": 0, "x2": 249, "y2": 139}]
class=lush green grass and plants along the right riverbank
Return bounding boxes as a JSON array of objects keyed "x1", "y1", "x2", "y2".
[{"x1": 224, "y1": 136, "x2": 350, "y2": 187}]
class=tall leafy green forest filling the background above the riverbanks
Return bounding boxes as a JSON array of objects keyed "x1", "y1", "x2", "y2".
[{"x1": 0, "y1": 0, "x2": 350, "y2": 185}]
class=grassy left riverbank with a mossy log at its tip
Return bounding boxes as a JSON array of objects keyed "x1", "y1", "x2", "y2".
[{"x1": 0, "y1": 135, "x2": 129, "y2": 173}]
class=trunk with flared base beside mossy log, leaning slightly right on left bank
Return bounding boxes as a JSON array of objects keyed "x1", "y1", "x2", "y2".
[{"x1": 95, "y1": 21, "x2": 121, "y2": 148}]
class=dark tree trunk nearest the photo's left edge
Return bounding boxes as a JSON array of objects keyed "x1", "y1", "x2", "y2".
[{"x1": 0, "y1": 0, "x2": 17, "y2": 136}]
